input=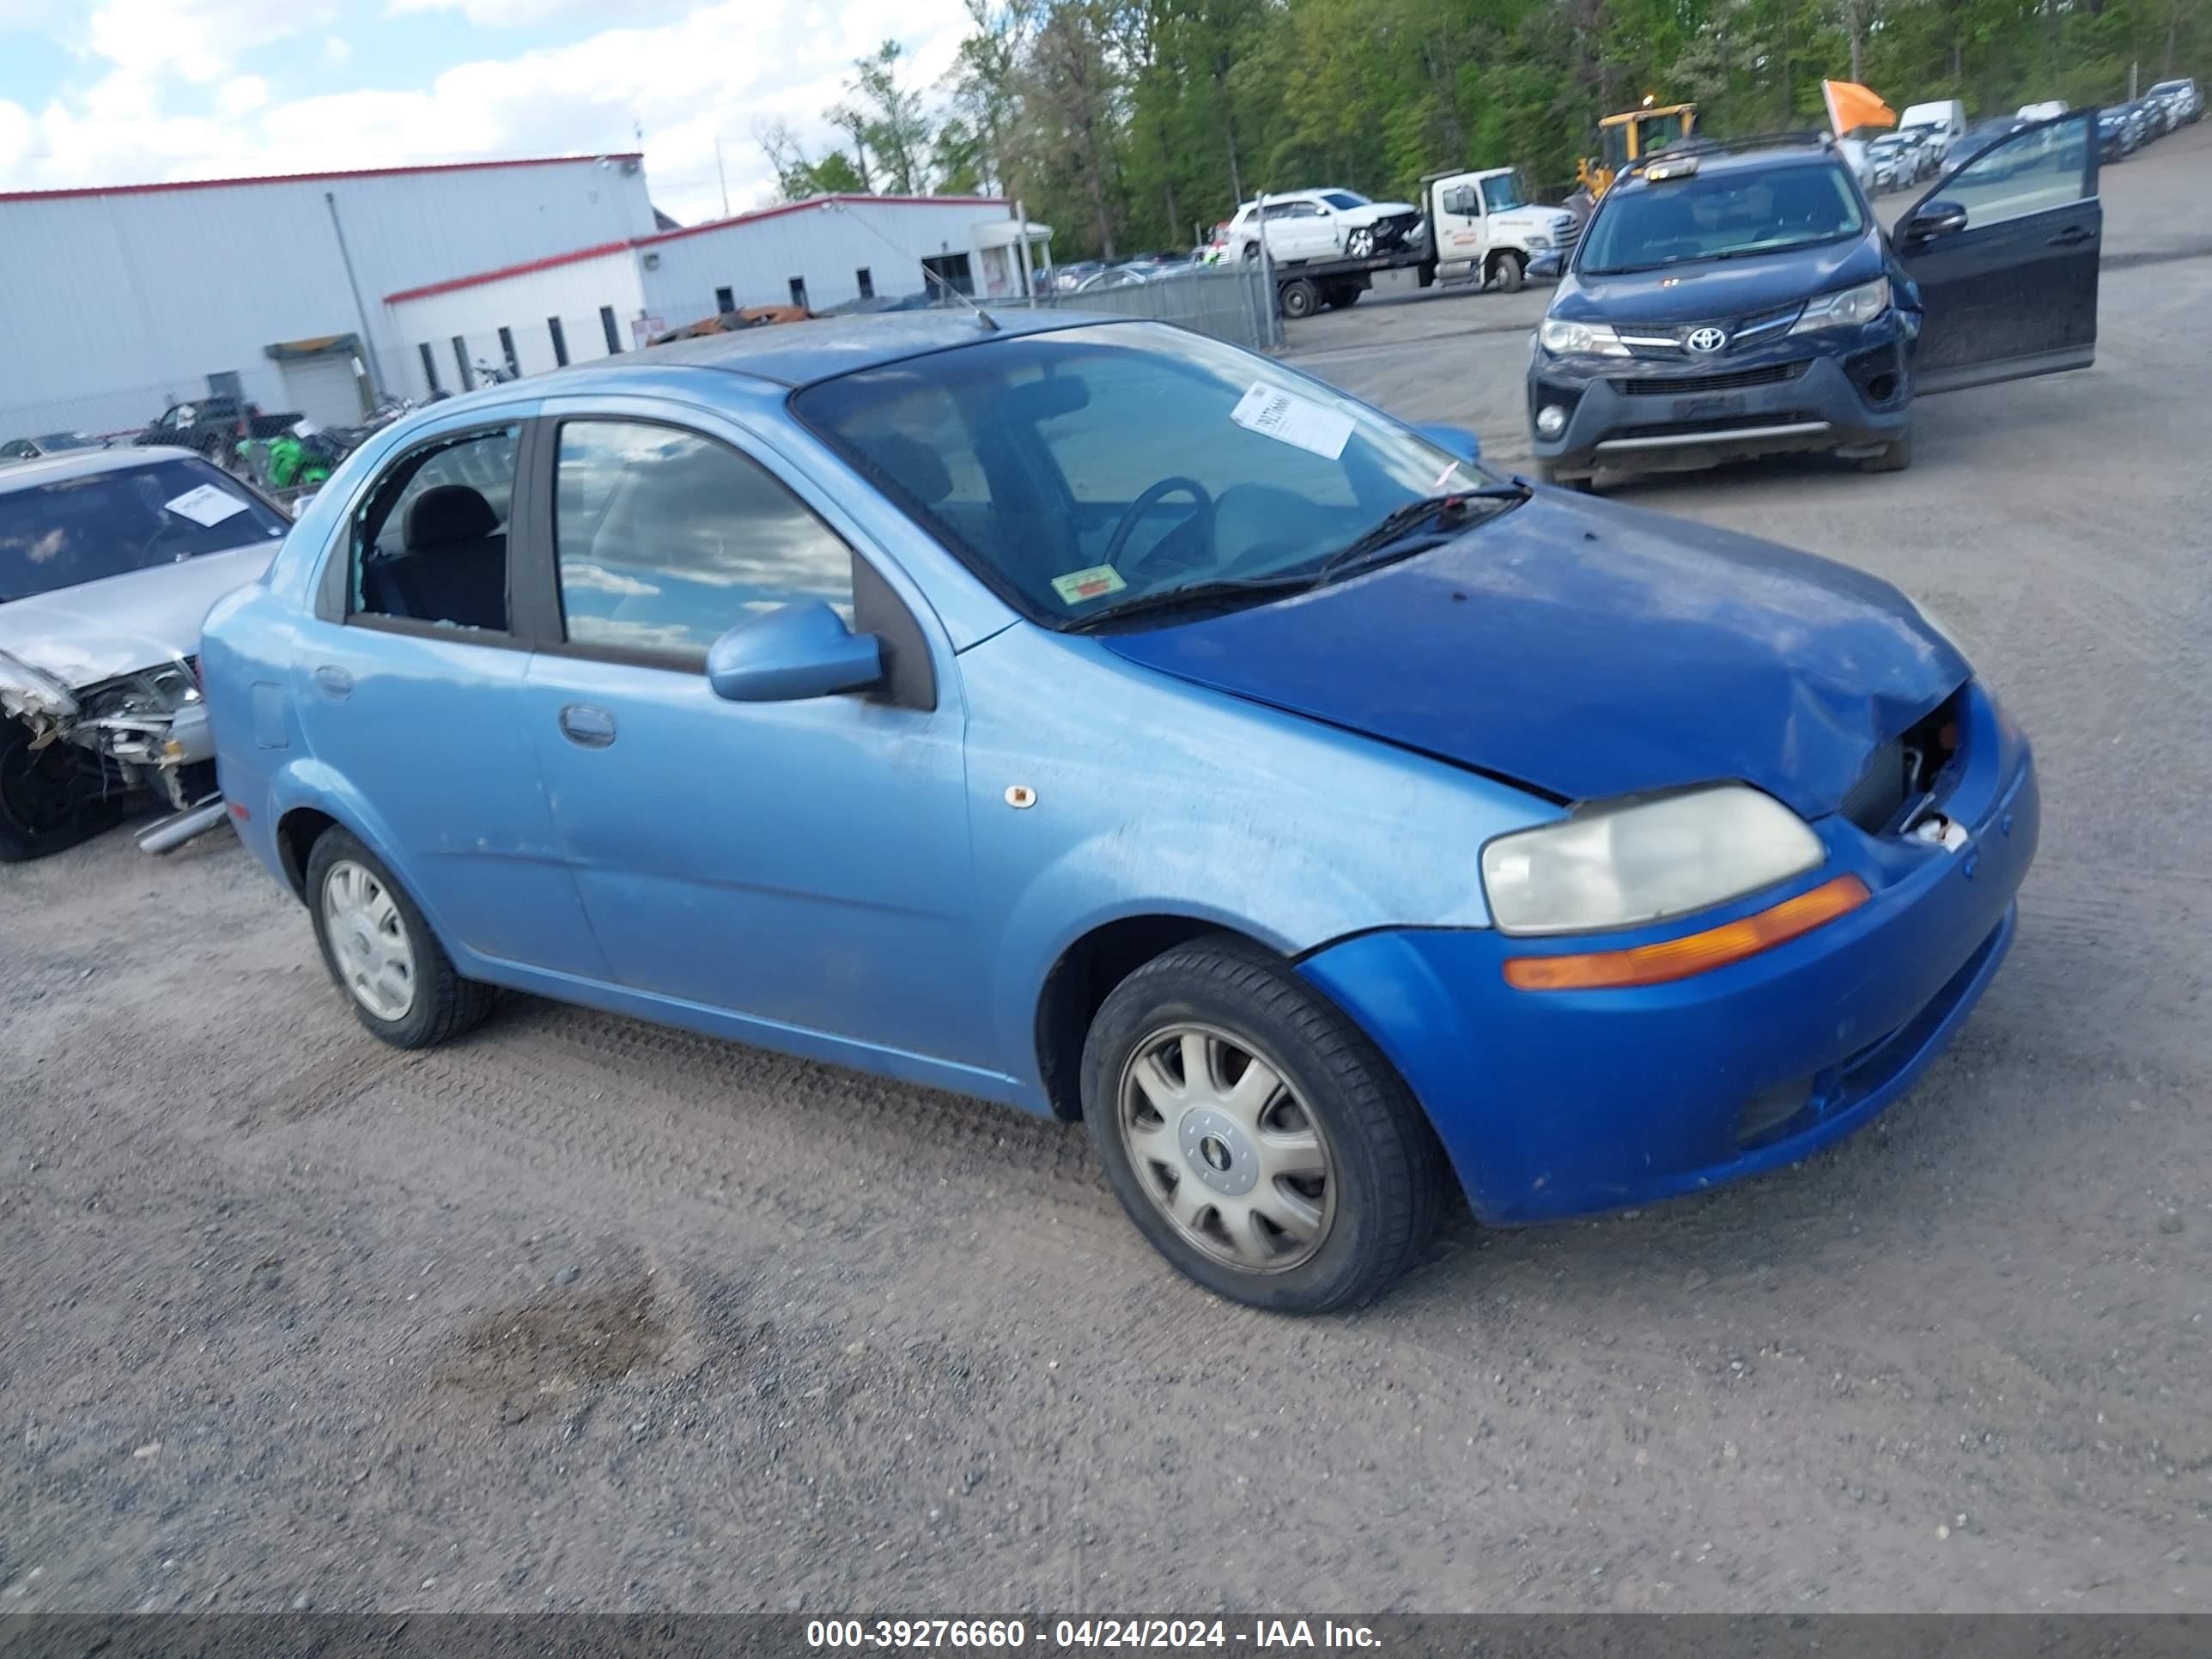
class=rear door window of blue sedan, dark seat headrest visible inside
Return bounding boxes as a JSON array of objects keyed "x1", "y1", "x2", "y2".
[{"x1": 352, "y1": 427, "x2": 522, "y2": 633}]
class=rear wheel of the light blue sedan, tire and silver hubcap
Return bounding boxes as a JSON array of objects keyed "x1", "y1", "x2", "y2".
[{"x1": 307, "y1": 830, "x2": 493, "y2": 1048}]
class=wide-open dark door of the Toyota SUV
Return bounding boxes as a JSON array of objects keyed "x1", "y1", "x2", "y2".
[{"x1": 1891, "y1": 108, "x2": 2104, "y2": 392}]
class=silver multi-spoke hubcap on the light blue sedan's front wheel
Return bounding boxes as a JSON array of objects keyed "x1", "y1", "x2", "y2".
[{"x1": 1117, "y1": 1024, "x2": 1336, "y2": 1272}]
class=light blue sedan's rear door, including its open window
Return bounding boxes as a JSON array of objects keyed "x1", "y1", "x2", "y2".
[{"x1": 292, "y1": 411, "x2": 604, "y2": 978}]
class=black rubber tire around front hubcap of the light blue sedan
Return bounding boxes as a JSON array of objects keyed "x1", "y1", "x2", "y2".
[{"x1": 1082, "y1": 936, "x2": 1444, "y2": 1314}]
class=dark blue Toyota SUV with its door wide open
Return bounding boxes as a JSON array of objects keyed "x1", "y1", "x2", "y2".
[{"x1": 1528, "y1": 108, "x2": 2104, "y2": 489}]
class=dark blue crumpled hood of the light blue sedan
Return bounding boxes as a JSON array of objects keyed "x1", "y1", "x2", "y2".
[{"x1": 1099, "y1": 493, "x2": 1971, "y2": 818}]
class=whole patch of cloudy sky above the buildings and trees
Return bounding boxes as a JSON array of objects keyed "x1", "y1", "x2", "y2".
[{"x1": 0, "y1": 0, "x2": 964, "y2": 223}]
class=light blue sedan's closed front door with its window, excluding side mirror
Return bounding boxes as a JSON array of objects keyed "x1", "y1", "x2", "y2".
[{"x1": 525, "y1": 409, "x2": 988, "y2": 1061}]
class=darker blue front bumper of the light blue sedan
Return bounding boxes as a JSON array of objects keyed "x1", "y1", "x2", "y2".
[{"x1": 1301, "y1": 688, "x2": 2039, "y2": 1224}]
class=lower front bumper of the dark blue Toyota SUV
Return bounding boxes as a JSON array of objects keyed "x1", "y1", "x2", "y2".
[{"x1": 1528, "y1": 310, "x2": 1917, "y2": 476}]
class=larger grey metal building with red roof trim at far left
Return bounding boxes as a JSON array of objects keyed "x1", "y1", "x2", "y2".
[{"x1": 0, "y1": 155, "x2": 654, "y2": 441}]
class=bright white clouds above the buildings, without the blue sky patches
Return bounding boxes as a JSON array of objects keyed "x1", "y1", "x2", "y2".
[{"x1": 0, "y1": 0, "x2": 967, "y2": 222}]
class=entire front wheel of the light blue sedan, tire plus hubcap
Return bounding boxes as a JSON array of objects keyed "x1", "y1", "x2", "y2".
[{"x1": 1084, "y1": 938, "x2": 1444, "y2": 1314}]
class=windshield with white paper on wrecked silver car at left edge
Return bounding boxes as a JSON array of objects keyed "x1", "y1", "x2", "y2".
[{"x1": 0, "y1": 456, "x2": 289, "y2": 602}]
